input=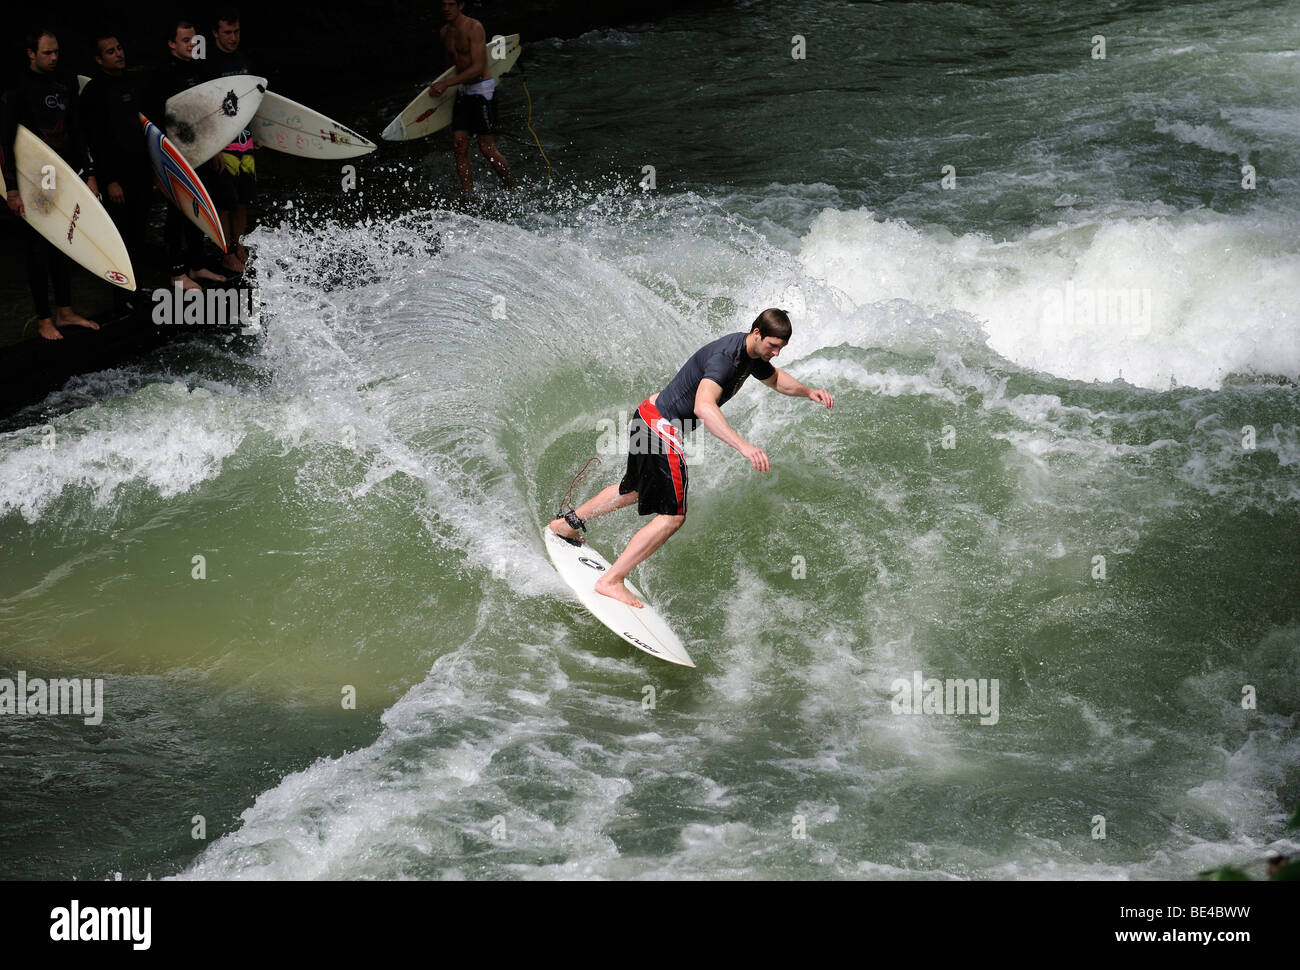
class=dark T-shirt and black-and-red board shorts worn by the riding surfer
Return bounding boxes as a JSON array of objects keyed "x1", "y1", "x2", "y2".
[{"x1": 619, "y1": 333, "x2": 776, "y2": 515}]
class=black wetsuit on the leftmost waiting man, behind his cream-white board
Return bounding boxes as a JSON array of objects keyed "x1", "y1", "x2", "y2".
[{"x1": 0, "y1": 69, "x2": 94, "y2": 320}]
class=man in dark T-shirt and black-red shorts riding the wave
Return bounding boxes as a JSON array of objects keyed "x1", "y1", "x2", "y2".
[{"x1": 551, "y1": 308, "x2": 835, "y2": 607}]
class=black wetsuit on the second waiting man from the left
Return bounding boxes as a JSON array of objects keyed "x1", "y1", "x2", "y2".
[{"x1": 81, "y1": 72, "x2": 153, "y2": 309}]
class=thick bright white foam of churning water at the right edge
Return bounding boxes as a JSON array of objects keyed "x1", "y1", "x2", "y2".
[{"x1": 800, "y1": 209, "x2": 1300, "y2": 390}]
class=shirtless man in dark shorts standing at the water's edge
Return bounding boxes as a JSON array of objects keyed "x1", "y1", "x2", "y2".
[{"x1": 429, "y1": 0, "x2": 515, "y2": 192}]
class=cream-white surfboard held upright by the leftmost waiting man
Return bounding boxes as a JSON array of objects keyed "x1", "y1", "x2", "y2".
[{"x1": 13, "y1": 125, "x2": 135, "y2": 290}]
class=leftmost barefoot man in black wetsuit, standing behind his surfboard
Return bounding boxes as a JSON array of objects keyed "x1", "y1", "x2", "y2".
[{"x1": 0, "y1": 29, "x2": 99, "y2": 341}]
